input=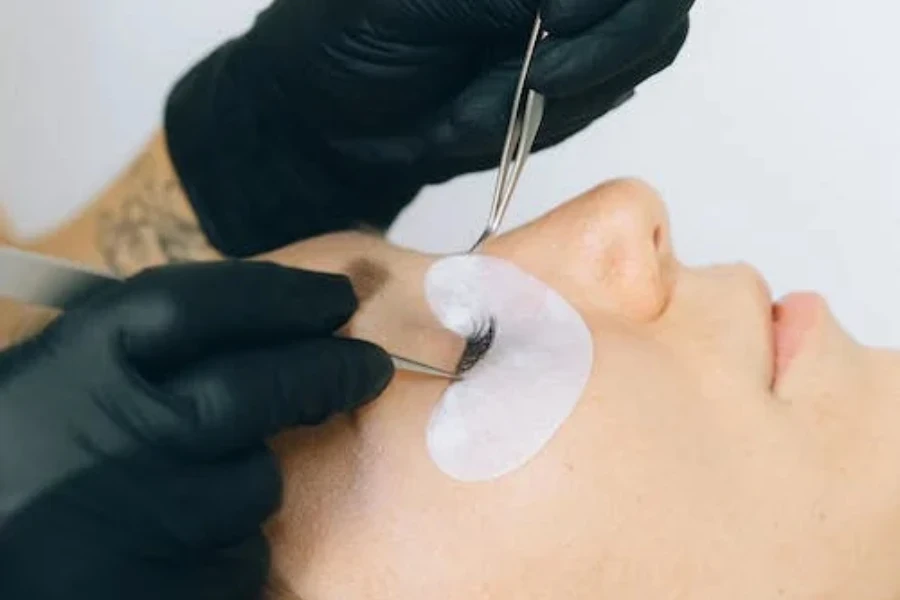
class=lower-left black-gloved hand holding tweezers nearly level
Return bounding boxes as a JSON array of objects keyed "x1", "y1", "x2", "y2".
[{"x1": 0, "y1": 263, "x2": 393, "y2": 600}]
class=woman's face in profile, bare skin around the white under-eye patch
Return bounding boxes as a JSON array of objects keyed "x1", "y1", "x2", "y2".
[{"x1": 256, "y1": 181, "x2": 900, "y2": 600}]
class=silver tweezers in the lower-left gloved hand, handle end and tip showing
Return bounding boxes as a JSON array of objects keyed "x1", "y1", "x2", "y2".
[{"x1": 0, "y1": 247, "x2": 461, "y2": 381}]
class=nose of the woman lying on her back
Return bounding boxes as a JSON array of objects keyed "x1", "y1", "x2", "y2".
[{"x1": 496, "y1": 179, "x2": 677, "y2": 321}]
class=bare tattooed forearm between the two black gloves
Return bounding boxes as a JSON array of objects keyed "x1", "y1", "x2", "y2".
[{"x1": 26, "y1": 133, "x2": 220, "y2": 276}]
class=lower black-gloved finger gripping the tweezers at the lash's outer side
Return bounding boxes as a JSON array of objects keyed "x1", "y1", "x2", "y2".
[{"x1": 162, "y1": 338, "x2": 394, "y2": 456}]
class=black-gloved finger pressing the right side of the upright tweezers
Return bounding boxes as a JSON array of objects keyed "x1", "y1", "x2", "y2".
[{"x1": 529, "y1": 0, "x2": 694, "y2": 97}]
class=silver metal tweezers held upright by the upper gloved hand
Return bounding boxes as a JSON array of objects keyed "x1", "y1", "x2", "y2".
[{"x1": 469, "y1": 14, "x2": 545, "y2": 253}]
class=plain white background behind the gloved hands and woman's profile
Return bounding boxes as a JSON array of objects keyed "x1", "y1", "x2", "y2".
[{"x1": 0, "y1": 0, "x2": 900, "y2": 345}]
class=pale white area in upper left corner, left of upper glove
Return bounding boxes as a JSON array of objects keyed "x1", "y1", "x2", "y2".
[{"x1": 0, "y1": 0, "x2": 267, "y2": 227}]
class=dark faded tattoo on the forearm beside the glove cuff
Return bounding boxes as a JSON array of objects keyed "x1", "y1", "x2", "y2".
[{"x1": 97, "y1": 157, "x2": 216, "y2": 276}]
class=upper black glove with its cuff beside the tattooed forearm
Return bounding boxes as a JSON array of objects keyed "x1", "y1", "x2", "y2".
[{"x1": 166, "y1": 0, "x2": 693, "y2": 255}]
